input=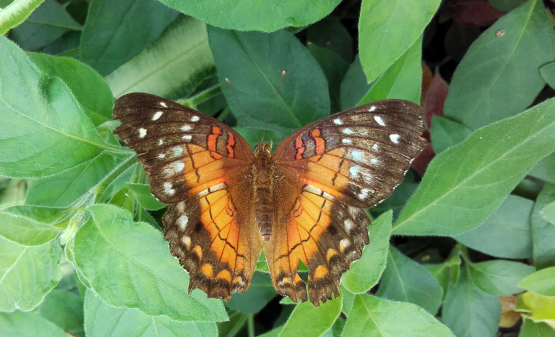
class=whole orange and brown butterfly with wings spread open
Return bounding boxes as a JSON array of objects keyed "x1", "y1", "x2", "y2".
[{"x1": 114, "y1": 93, "x2": 425, "y2": 306}]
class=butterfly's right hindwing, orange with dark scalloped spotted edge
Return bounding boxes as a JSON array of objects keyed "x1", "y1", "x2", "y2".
[{"x1": 263, "y1": 179, "x2": 371, "y2": 306}]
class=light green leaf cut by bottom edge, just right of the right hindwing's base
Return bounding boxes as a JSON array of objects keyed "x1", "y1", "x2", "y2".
[{"x1": 343, "y1": 294, "x2": 455, "y2": 337}]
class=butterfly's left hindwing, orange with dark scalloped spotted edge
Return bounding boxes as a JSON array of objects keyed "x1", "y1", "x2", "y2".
[{"x1": 163, "y1": 179, "x2": 261, "y2": 301}]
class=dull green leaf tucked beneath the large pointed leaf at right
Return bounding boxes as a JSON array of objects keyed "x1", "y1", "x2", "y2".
[{"x1": 453, "y1": 195, "x2": 535, "y2": 259}]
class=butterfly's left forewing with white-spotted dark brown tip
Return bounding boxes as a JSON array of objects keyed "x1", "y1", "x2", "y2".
[{"x1": 114, "y1": 93, "x2": 253, "y2": 204}]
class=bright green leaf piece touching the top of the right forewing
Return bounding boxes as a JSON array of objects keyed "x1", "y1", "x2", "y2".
[{"x1": 357, "y1": 38, "x2": 423, "y2": 105}]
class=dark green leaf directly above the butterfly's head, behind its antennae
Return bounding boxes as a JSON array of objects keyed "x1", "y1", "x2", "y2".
[{"x1": 208, "y1": 27, "x2": 330, "y2": 143}]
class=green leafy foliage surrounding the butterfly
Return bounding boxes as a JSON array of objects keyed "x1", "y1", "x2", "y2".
[{"x1": 0, "y1": 0, "x2": 555, "y2": 337}]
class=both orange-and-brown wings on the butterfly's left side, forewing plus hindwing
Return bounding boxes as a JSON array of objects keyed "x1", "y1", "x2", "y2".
[{"x1": 114, "y1": 93, "x2": 261, "y2": 300}]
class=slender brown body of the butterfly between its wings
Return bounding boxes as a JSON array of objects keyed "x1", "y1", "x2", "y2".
[{"x1": 253, "y1": 143, "x2": 276, "y2": 241}]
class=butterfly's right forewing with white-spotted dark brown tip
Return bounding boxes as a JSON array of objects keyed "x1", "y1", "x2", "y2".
[{"x1": 273, "y1": 100, "x2": 426, "y2": 208}]
